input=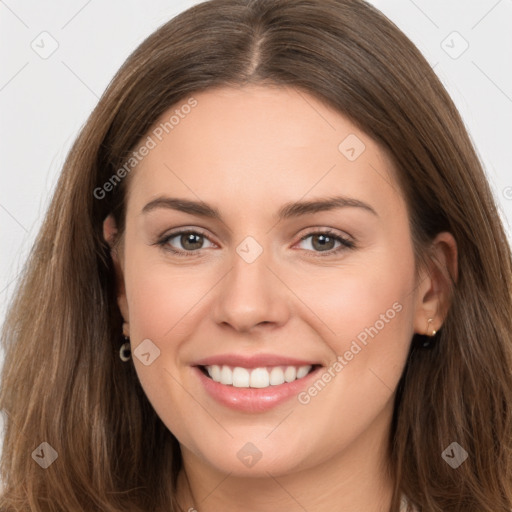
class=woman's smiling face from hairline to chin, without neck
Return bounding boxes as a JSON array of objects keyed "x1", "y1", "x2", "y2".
[{"x1": 110, "y1": 86, "x2": 430, "y2": 476}]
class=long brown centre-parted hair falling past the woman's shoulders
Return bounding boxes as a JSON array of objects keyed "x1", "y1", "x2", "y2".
[{"x1": 0, "y1": 0, "x2": 512, "y2": 512}]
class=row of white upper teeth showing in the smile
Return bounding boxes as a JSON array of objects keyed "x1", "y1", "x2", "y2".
[{"x1": 205, "y1": 364, "x2": 312, "y2": 388}]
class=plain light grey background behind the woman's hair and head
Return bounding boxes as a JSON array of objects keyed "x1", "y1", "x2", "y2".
[{"x1": 0, "y1": 0, "x2": 512, "y2": 460}]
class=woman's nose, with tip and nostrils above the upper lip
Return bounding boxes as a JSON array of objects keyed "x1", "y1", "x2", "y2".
[{"x1": 213, "y1": 242, "x2": 290, "y2": 333}]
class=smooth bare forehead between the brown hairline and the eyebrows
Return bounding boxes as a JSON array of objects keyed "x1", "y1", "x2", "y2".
[{"x1": 129, "y1": 85, "x2": 404, "y2": 218}]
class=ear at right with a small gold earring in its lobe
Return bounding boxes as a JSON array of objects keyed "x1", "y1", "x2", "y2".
[{"x1": 414, "y1": 232, "x2": 458, "y2": 336}]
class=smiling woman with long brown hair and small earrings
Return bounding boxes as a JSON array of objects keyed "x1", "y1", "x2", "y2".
[{"x1": 0, "y1": 0, "x2": 512, "y2": 512}]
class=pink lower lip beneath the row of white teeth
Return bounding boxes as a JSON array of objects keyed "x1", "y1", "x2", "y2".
[{"x1": 193, "y1": 366, "x2": 321, "y2": 412}]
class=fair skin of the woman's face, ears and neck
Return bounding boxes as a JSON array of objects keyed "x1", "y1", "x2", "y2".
[{"x1": 104, "y1": 85, "x2": 457, "y2": 512}]
